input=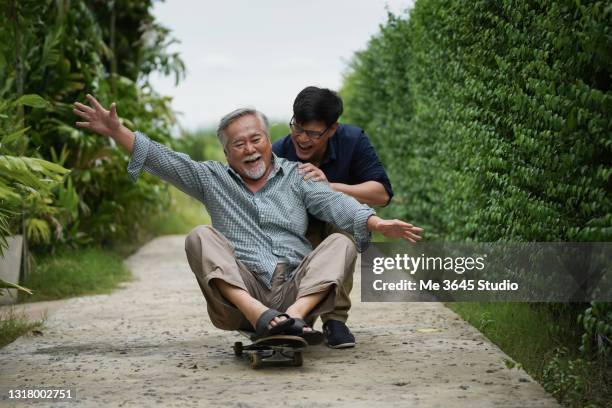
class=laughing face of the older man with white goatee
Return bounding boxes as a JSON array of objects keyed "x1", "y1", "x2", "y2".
[{"x1": 225, "y1": 115, "x2": 272, "y2": 181}]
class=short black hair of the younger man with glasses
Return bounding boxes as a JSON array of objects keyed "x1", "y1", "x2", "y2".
[{"x1": 293, "y1": 86, "x2": 343, "y2": 126}]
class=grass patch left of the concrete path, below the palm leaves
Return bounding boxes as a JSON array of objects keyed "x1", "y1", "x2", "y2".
[{"x1": 19, "y1": 248, "x2": 131, "y2": 302}]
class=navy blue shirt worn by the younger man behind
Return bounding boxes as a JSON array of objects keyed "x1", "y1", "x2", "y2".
[{"x1": 272, "y1": 124, "x2": 393, "y2": 204}]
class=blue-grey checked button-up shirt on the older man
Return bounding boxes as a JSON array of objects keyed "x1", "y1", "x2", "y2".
[{"x1": 128, "y1": 132, "x2": 375, "y2": 287}]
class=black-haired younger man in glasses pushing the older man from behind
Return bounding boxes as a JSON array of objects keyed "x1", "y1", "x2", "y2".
[{"x1": 272, "y1": 86, "x2": 393, "y2": 348}]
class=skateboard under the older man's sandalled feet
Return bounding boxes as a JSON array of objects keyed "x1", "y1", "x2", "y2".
[{"x1": 233, "y1": 330, "x2": 308, "y2": 368}]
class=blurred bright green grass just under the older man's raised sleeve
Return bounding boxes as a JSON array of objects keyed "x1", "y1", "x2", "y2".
[{"x1": 151, "y1": 186, "x2": 210, "y2": 236}]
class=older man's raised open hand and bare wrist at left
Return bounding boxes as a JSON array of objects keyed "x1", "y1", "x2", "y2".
[{"x1": 74, "y1": 94, "x2": 136, "y2": 154}]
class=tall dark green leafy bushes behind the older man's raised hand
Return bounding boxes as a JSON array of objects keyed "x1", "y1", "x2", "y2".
[{"x1": 0, "y1": 0, "x2": 184, "y2": 249}]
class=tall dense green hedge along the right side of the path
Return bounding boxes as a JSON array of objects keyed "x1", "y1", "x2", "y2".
[{"x1": 341, "y1": 0, "x2": 612, "y2": 405}]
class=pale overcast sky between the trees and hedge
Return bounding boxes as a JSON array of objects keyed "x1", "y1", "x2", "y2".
[{"x1": 152, "y1": 0, "x2": 413, "y2": 129}]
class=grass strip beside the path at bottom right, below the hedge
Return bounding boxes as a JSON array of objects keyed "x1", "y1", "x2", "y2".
[{"x1": 446, "y1": 302, "x2": 612, "y2": 407}]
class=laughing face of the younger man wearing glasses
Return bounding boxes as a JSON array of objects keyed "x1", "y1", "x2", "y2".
[{"x1": 291, "y1": 119, "x2": 338, "y2": 165}]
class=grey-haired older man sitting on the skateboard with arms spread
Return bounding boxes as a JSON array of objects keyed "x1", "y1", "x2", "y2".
[{"x1": 74, "y1": 95, "x2": 422, "y2": 344}]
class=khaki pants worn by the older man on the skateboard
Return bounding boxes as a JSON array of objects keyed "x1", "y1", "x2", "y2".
[{"x1": 185, "y1": 225, "x2": 357, "y2": 330}]
